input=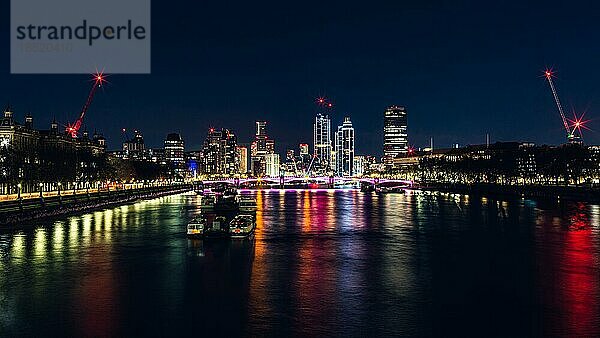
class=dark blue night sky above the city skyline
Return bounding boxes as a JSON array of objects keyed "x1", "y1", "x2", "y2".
[{"x1": 0, "y1": 1, "x2": 600, "y2": 155}]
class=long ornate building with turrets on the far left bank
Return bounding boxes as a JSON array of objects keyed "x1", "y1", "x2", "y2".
[{"x1": 0, "y1": 107, "x2": 106, "y2": 193}]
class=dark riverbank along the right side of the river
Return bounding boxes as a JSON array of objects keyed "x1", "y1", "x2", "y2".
[{"x1": 420, "y1": 184, "x2": 600, "y2": 203}]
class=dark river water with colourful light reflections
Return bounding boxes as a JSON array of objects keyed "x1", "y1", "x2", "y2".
[{"x1": 0, "y1": 191, "x2": 600, "y2": 337}]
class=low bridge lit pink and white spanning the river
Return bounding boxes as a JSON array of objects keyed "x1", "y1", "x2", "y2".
[{"x1": 201, "y1": 176, "x2": 414, "y2": 187}]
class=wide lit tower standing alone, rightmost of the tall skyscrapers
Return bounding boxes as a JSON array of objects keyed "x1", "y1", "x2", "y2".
[{"x1": 383, "y1": 106, "x2": 408, "y2": 165}]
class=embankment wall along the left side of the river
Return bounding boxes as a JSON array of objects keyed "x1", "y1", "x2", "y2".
[{"x1": 0, "y1": 184, "x2": 192, "y2": 226}]
